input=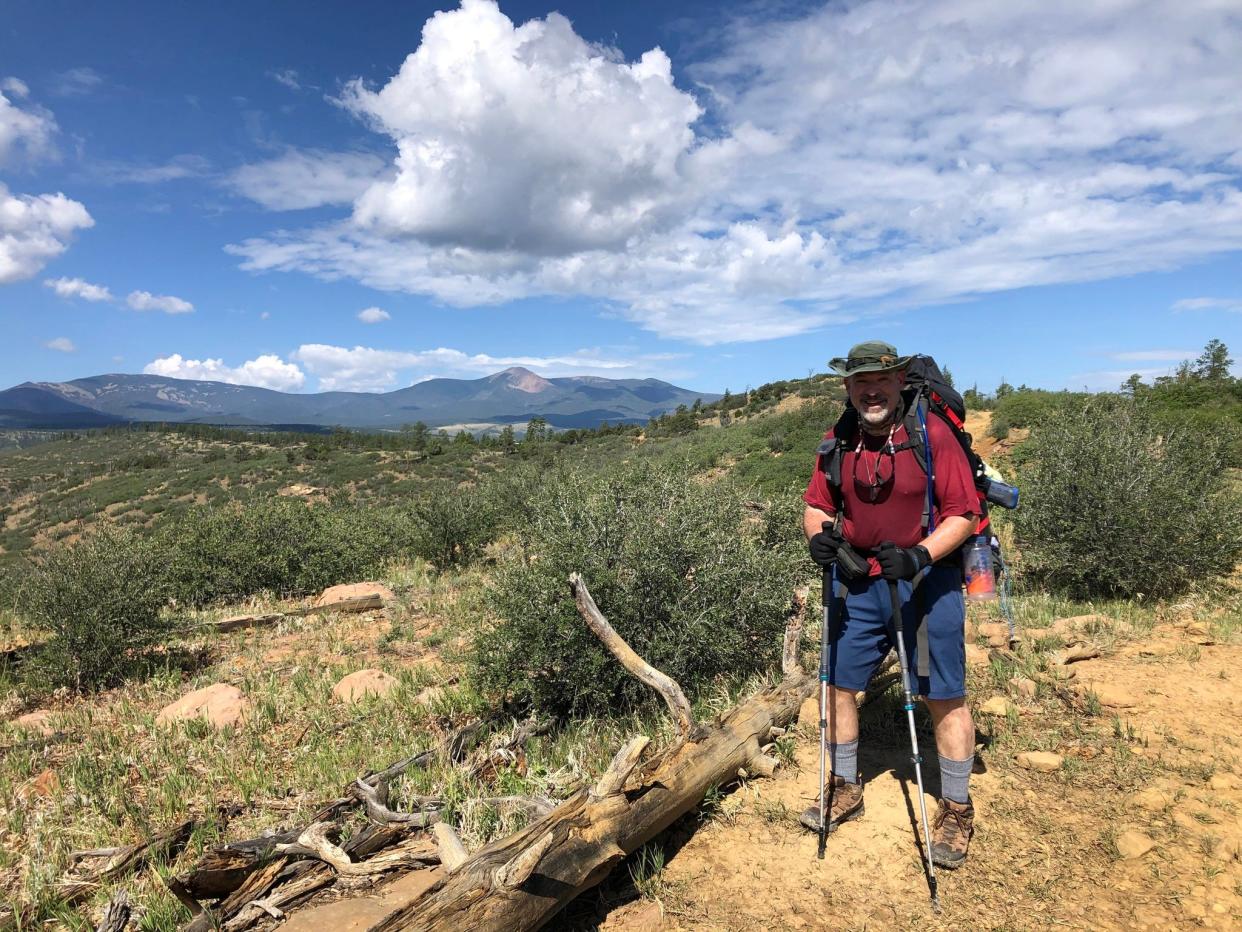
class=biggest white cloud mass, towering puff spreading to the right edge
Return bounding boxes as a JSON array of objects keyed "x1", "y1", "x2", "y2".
[{"x1": 230, "y1": 0, "x2": 1242, "y2": 343}]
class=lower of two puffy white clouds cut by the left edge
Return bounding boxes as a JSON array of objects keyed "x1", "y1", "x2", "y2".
[{"x1": 0, "y1": 181, "x2": 94, "y2": 285}]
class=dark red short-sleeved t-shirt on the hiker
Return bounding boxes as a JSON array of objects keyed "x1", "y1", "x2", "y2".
[{"x1": 802, "y1": 416, "x2": 981, "y2": 575}]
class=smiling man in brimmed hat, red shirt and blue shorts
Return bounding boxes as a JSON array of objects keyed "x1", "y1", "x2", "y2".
[{"x1": 801, "y1": 342, "x2": 982, "y2": 869}]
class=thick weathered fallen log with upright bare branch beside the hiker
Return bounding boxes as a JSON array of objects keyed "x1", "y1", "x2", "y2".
[{"x1": 369, "y1": 574, "x2": 814, "y2": 932}]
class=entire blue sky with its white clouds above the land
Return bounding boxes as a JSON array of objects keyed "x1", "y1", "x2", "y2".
[{"x1": 0, "y1": 0, "x2": 1242, "y2": 391}]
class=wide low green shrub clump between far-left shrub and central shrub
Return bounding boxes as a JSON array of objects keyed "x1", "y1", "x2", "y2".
[{"x1": 156, "y1": 496, "x2": 415, "y2": 605}]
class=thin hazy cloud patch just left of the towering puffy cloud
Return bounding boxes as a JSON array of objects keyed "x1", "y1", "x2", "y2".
[{"x1": 226, "y1": 149, "x2": 385, "y2": 210}]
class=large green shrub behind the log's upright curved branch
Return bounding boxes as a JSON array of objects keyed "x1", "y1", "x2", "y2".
[{"x1": 474, "y1": 464, "x2": 806, "y2": 716}]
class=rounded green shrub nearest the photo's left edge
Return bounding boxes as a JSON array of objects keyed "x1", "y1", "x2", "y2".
[{"x1": 17, "y1": 524, "x2": 173, "y2": 690}]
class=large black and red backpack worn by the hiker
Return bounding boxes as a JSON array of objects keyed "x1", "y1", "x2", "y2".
[{"x1": 816, "y1": 355, "x2": 1016, "y2": 533}]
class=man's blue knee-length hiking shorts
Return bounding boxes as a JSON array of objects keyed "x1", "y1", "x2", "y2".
[{"x1": 828, "y1": 567, "x2": 966, "y2": 700}]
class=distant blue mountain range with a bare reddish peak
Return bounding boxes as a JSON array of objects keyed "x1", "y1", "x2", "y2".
[{"x1": 0, "y1": 367, "x2": 719, "y2": 430}]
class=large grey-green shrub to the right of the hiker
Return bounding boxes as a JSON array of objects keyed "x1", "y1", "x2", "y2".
[{"x1": 1013, "y1": 395, "x2": 1242, "y2": 598}]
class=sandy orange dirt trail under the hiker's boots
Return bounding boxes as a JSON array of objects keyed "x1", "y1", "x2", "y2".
[{"x1": 604, "y1": 628, "x2": 1242, "y2": 930}]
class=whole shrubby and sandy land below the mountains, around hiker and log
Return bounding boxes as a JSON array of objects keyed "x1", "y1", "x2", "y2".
[{"x1": 0, "y1": 344, "x2": 1242, "y2": 930}]
